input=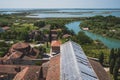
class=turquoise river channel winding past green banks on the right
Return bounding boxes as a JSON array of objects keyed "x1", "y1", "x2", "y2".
[{"x1": 65, "y1": 21, "x2": 120, "y2": 49}]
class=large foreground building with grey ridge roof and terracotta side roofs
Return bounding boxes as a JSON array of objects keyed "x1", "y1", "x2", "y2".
[{"x1": 46, "y1": 41, "x2": 110, "y2": 80}]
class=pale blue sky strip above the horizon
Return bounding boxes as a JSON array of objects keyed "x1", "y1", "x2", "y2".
[{"x1": 0, "y1": 0, "x2": 120, "y2": 8}]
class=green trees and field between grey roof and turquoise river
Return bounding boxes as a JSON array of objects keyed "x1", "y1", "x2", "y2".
[{"x1": 71, "y1": 32, "x2": 110, "y2": 65}]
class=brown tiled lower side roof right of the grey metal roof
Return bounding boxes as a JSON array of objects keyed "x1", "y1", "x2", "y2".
[{"x1": 89, "y1": 59, "x2": 110, "y2": 80}]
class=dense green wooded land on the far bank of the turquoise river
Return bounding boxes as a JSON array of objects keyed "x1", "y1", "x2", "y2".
[{"x1": 80, "y1": 16, "x2": 120, "y2": 40}]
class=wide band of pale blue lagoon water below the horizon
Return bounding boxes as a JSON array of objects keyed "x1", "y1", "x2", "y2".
[{"x1": 0, "y1": 8, "x2": 120, "y2": 18}]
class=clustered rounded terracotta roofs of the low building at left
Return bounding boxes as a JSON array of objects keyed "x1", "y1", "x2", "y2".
[{"x1": 3, "y1": 42, "x2": 39, "y2": 61}]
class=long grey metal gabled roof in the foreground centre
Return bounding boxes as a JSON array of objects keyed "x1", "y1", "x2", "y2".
[{"x1": 60, "y1": 41, "x2": 99, "y2": 80}]
